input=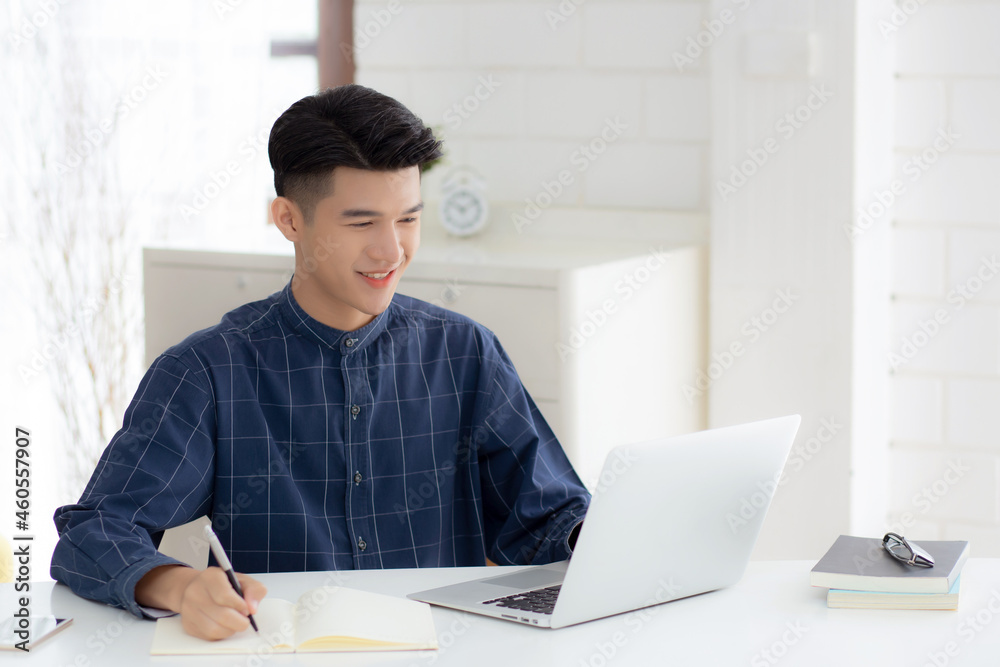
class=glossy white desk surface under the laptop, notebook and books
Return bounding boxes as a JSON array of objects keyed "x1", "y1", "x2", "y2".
[{"x1": 0, "y1": 559, "x2": 1000, "y2": 667}]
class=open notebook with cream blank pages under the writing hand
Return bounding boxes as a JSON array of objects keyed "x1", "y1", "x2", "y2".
[{"x1": 149, "y1": 586, "x2": 437, "y2": 655}]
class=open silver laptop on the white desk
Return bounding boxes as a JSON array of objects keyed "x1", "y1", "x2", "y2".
[{"x1": 408, "y1": 415, "x2": 801, "y2": 628}]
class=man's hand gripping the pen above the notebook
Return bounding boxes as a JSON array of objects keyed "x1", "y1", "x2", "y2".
[{"x1": 135, "y1": 565, "x2": 267, "y2": 640}]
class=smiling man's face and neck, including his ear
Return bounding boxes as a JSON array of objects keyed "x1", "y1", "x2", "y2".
[{"x1": 283, "y1": 167, "x2": 423, "y2": 331}]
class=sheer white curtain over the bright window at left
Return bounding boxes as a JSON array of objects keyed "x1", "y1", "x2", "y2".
[{"x1": 0, "y1": 0, "x2": 316, "y2": 578}]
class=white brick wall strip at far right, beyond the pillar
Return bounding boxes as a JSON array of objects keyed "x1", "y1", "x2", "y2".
[{"x1": 889, "y1": 0, "x2": 1000, "y2": 557}]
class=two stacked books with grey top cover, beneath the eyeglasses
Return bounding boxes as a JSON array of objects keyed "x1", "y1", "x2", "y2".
[{"x1": 809, "y1": 535, "x2": 969, "y2": 609}]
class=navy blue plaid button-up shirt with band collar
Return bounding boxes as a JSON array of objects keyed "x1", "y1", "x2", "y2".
[{"x1": 51, "y1": 283, "x2": 590, "y2": 615}]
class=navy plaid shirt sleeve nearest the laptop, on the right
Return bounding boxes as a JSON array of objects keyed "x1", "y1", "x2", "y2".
[{"x1": 474, "y1": 336, "x2": 590, "y2": 565}]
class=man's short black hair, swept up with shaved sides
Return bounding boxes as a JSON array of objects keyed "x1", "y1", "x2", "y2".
[{"x1": 267, "y1": 83, "x2": 443, "y2": 223}]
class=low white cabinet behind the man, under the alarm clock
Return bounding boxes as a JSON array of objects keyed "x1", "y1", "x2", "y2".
[{"x1": 143, "y1": 240, "x2": 707, "y2": 486}]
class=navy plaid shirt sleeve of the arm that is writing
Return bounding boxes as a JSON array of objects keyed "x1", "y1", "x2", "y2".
[{"x1": 50, "y1": 356, "x2": 215, "y2": 618}]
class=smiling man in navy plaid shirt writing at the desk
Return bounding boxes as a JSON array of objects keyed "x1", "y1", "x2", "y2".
[{"x1": 51, "y1": 85, "x2": 590, "y2": 639}]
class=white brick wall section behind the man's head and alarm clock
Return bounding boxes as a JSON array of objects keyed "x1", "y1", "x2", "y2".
[{"x1": 355, "y1": 0, "x2": 709, "y2": 242}]
